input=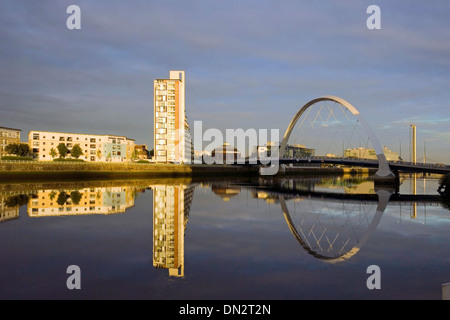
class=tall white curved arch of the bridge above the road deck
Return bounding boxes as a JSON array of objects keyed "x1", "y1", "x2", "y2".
[{"x1": 280, "y1": 96, "x2": 395, "y2": 179}]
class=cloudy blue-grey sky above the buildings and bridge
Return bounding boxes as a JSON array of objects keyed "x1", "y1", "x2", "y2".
[{"x1": 0, "y1": 0, "x2": 450, "y2": 164}]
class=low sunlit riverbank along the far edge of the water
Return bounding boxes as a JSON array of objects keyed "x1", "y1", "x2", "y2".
[{"x1": 0, "y1": 161, "x2": 374, "y2": 182}]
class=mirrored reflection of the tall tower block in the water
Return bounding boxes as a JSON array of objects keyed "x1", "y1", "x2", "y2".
[{"x1": 152, "y1": 185, "x2": 195, "y2": 277}]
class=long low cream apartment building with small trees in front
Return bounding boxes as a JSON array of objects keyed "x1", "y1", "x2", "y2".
[{"x1": 28, "y1": 131, "x2": 135, "y2": 162}]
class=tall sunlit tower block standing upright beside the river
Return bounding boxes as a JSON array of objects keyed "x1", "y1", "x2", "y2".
[{"x1": 153, "y1": 71, "x2": 193, "y2": 163}]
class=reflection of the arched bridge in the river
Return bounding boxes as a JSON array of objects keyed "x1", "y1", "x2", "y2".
[{"x1": 217, "y1": 174, "x2": 442, "y2": 263}]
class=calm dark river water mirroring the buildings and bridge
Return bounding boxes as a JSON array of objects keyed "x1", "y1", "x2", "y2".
[{"x1": 0, "y1": 176, "x2": 450, "y2": 300}]
